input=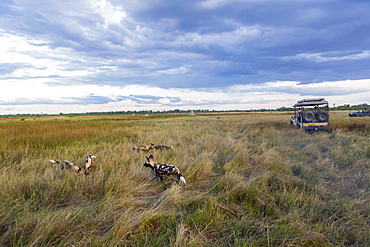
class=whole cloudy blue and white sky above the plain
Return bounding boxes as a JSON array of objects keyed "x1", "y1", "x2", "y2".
[{"x1": 0, "y1": 0, "x2": 370, "y2": 114}]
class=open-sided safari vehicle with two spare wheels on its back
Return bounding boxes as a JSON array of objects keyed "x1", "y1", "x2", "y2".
[{"x1": 290, "y1": 98, "x2": 329, "y2": 132}]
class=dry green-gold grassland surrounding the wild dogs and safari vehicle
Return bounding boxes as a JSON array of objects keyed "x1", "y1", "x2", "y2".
[{"x1": 0, "y1": 112, "x2": 370, "y2": 246}]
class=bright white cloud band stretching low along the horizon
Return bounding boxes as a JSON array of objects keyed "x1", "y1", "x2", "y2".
[{"x1": 0, "y1": 80, "x2": 370, "y2": 113}]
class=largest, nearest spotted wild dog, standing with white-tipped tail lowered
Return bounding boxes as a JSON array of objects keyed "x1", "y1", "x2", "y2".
[{"x1": 144, "y1": 155, "x2": 186, "y2": 189}]
